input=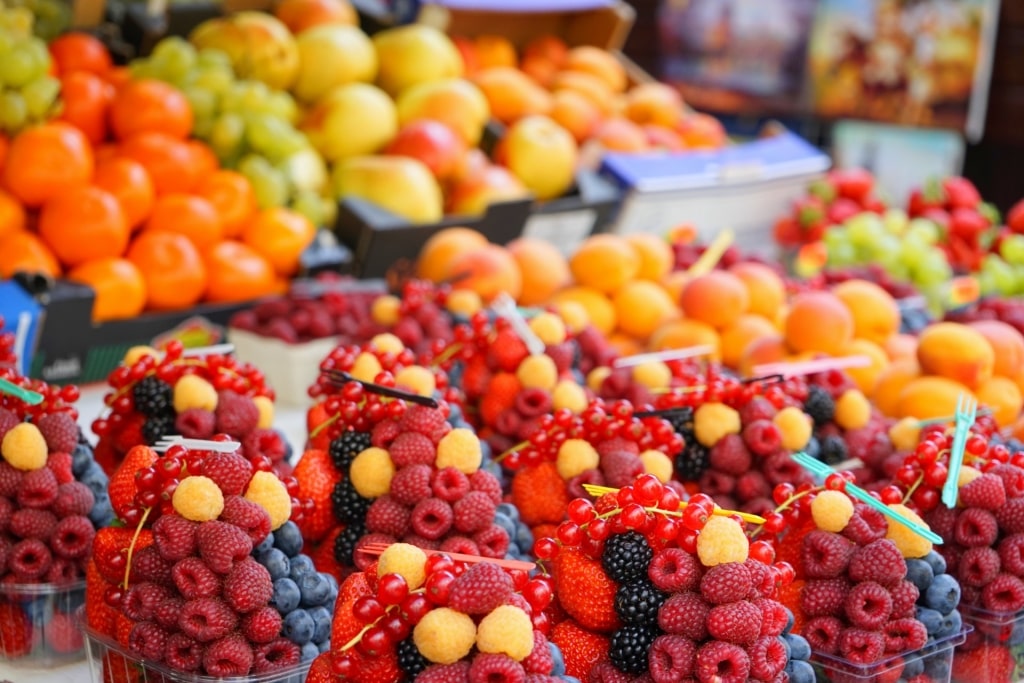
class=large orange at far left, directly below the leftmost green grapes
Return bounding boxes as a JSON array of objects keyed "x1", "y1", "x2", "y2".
[{"x1": 3, "y1": 122, "x2": 93, "y2": 207}]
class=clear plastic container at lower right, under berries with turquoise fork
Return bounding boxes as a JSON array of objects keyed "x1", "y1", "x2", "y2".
[{"x1": 811, "y1": 627, "x2": 966, "y2": 683}]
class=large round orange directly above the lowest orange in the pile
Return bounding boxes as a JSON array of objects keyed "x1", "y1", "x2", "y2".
[{"x1": 39, "y1": 185, "x2": 129, "y2": 266}]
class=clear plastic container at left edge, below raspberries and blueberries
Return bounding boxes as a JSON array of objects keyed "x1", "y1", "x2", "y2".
[{"x1": 0, "y1": 581, "x2": 85, "y2": 669}]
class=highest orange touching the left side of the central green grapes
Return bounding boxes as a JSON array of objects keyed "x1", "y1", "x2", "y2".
[{"x1": 111, "y1": 79, "x2": 193, "y2": 140}]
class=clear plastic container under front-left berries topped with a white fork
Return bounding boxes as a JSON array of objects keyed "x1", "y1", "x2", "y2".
[{"x1": 82, "y1": 626, "x2": 312, "y2": 683}]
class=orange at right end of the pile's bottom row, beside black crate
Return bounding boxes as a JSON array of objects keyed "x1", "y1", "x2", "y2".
[{"x1": 203, "y1": 240, "x2": 278, "y2": 301}]
